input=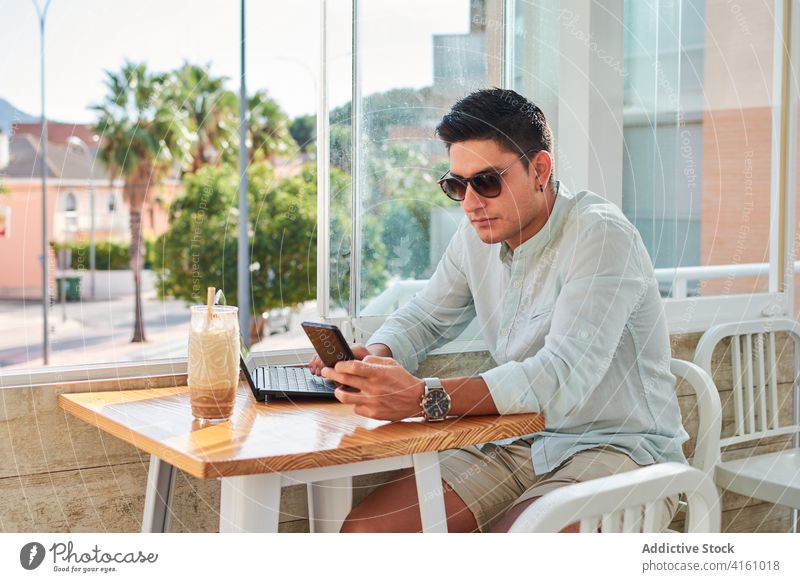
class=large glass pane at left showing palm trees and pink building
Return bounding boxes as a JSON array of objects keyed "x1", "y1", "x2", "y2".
[{"x1": 0, "y1": 0, "x2": 322, "y2": 374}]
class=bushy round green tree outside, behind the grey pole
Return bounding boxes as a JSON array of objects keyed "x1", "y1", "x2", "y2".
[{"x1": 155, "y1": 162, "x2": 386, "y2": 313}]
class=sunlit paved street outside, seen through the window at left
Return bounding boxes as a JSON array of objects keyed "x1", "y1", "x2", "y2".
[{"x1": 0, "y1": 293, "x2": 317, "y2": 371}]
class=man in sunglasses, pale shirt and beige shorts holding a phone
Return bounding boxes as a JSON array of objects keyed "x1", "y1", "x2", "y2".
[{"x1": 310, "y1": 89, "x2": 688, "y2": 532}]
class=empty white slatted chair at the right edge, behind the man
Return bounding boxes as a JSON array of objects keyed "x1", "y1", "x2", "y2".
[{"x1": 694, "y1": 319, "x2": 800, "y2": 532}]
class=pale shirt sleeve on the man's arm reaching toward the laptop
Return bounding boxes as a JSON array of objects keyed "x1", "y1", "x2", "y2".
[{"x1": 369, "y1": 224, "x2": 475, "y2": 372}]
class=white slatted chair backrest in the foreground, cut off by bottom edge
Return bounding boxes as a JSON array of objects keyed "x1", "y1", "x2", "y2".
[{"x1": 509, "y1": 463, "x2": 720, "y2": 533}]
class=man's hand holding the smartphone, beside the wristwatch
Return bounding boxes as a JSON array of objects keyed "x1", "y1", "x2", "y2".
[{"x1": 322, "y1": 355, "x2": 425, "y2": 420}]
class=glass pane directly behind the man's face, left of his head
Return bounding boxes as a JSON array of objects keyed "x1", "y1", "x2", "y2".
[{"x1": 355, "y1": 0, "x2": 502, "y2": 315}]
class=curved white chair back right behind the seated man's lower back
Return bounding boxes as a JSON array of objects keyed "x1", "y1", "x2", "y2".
[{"x1": 670, "y1": 358, "x2": 722, "y2": 474}]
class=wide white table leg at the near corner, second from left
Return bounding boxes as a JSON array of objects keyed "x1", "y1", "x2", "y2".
[{"x1": 219, "y1": 473, "x2": 281, "y2": 533}]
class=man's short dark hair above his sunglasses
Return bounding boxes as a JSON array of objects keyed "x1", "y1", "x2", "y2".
[{"x1": 436, "y1": 87, "x2": 553, "y2": 180}]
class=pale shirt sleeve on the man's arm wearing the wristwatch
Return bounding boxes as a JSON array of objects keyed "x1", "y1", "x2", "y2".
[{"x1": 481, "y1": 220, "x2": 655, "y2": 425}]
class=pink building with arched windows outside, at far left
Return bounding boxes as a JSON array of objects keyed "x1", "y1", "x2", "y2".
[{"x1": 0, "y1": 122, "x2": 181, "y2": 299}]
